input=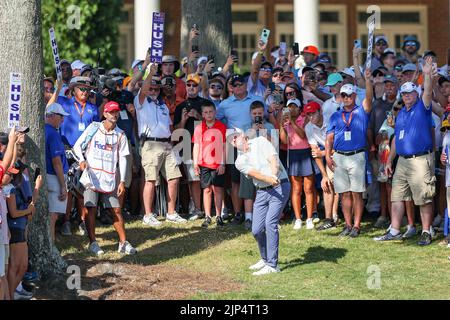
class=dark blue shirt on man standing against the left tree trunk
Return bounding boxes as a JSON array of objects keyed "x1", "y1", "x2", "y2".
[{"x1": 45, "y1": 124, "x2": 69, "y2": 175}]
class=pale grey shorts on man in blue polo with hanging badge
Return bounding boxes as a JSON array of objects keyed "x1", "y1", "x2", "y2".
[{"x1": 333, "y1": 152, "x2": 366, "y2": 193}]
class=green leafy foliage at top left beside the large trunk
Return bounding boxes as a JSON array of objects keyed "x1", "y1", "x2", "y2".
[{"x1": 42, "y1": 0, "x2": 123, "y2": 76}]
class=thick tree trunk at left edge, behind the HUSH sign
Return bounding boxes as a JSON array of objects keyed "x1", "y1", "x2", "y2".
[{"x1": 0, "y1": 0, "x2": 66, "y2": 276}]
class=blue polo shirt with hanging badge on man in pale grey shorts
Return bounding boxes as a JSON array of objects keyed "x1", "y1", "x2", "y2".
[{"x1": 327, "y1": 106, "x2": 370, "y2": 152}]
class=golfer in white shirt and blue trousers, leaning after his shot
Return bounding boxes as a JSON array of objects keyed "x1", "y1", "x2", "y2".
[{"x1": 227, "y1": 129, "x2": 291, "y2": 276}]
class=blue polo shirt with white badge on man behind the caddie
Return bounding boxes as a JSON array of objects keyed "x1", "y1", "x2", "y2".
[{"x1": 57, "y1": 97, "x2": 100, "y2": 147}]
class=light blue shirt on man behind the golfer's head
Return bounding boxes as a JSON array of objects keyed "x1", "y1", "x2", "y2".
[{"x1": 216, "y1": 94, "x2": 265, "y2": 129}]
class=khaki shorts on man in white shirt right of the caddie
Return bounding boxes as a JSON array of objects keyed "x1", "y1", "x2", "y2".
[{"x1": 141, "y1": 141, "x2": 181, "y2": 181}]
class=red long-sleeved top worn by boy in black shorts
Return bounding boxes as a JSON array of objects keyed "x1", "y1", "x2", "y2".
[{"x1": 192, "y1": 120, "x2": 227, "y2": 170}]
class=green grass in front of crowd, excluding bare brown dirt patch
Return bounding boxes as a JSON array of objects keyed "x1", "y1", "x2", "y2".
[{"x1": 58, "y1": 221, "x2": 450, "y2": 300}]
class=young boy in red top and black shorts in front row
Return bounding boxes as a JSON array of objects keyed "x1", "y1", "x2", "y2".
[{"x1": 192, "y1": 100, "x2": 226, "y2": 228}]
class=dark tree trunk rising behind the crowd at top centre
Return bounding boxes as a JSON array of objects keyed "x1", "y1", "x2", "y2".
[{"x1": 180, "y1": 0, "x2": 233, "y2": 67}]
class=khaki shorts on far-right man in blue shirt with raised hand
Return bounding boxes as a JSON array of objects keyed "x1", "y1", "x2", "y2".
[{"x1": 391, "y1": 154, "x2": 436, "y2": 206}]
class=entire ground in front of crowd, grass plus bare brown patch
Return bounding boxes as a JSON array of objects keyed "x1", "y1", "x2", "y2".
[{"x1": 42, "y1": 221, "x2": 450, "y2": 300}]
